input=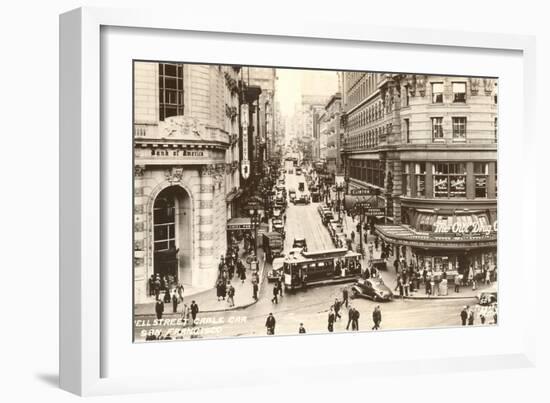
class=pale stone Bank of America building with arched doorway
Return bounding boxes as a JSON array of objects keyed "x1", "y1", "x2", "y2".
[{"x1": 134, "y1": 62, "x2": 241, "y2": 303}]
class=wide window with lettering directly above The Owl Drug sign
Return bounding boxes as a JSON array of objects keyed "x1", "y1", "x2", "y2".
[{"x1": 432, "y1": 163, "x2": 466, "y2": 198}]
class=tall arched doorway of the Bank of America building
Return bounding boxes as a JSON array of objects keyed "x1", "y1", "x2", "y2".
[{"x1": 152, "y1": 186, "x2": 193, "y2": 285}]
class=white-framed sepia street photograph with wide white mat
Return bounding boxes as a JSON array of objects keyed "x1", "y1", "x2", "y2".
[{"x1": 60, "y1": 9, "x2": 536, "y2": 395}]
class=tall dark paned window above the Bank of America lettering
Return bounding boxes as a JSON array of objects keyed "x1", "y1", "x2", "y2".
[{"x1": 159, "y1": 63, "x2": 183, "y2": 120}]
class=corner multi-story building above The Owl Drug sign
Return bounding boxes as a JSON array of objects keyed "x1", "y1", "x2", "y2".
[{"x1": 343, "y1": 72, "x2": 497, "y2": 270}]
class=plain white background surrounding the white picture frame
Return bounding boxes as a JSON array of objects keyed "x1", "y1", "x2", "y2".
[{"x1": 0, "y1": 0, "x2": 550, "y2": 402}]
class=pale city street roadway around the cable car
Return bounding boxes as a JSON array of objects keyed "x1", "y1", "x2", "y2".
[{"x1": 134, "y1": 174, "x2": 492, "y2": 340}]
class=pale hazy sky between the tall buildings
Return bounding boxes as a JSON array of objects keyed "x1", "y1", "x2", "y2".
[{"x1": 275, "y1": 69, "x2": 338, "y2": 117}]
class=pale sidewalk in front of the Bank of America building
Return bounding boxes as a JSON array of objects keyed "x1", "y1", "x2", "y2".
[{"x1": 134, "y1": 248, "x2": 266, "y2": 317}]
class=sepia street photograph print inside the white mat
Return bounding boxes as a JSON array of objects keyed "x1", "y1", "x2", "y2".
[{"x1": 131, "y1": 60, "x2": 498, "y2": 342}]
